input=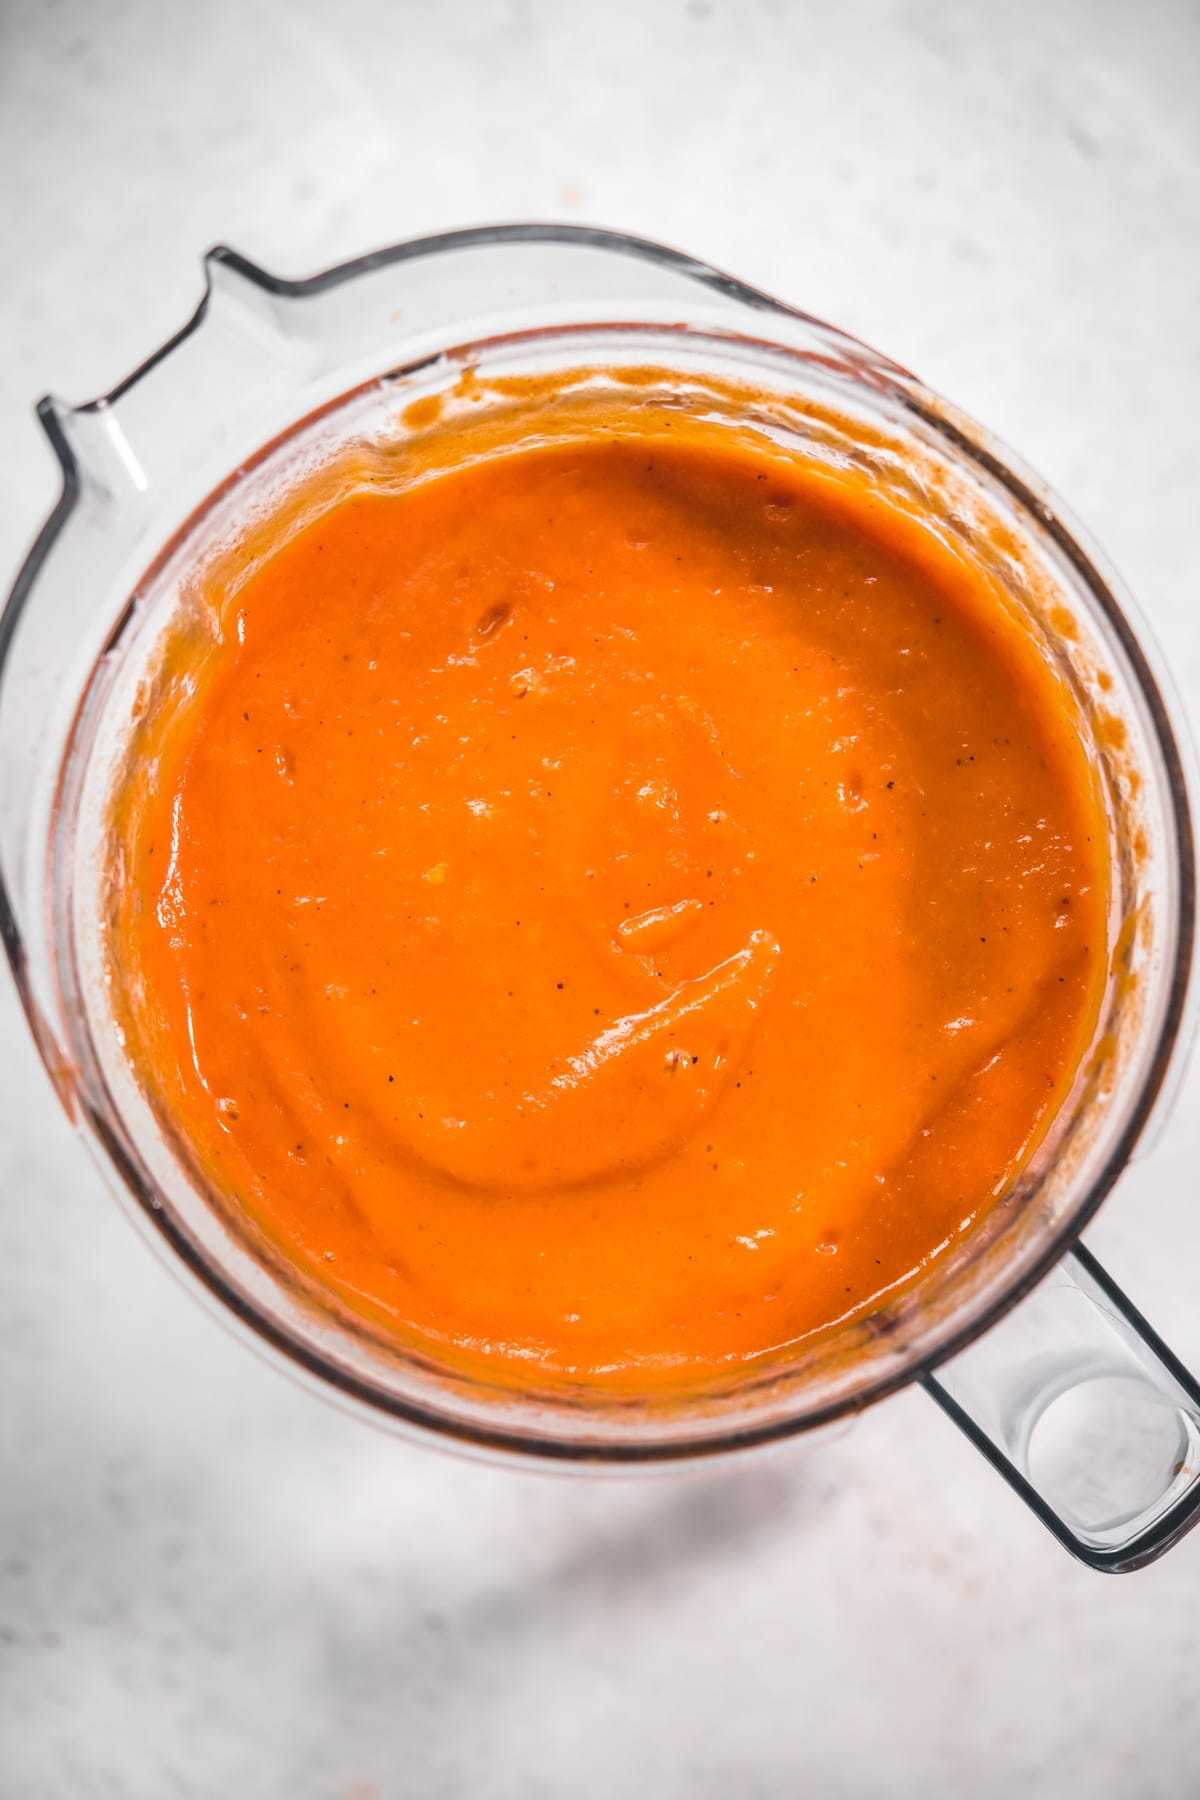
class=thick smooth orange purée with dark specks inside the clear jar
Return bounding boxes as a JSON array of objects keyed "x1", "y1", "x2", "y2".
[{"x1": 113, "y1": 424, "x2": 1106, "y2": 1379}]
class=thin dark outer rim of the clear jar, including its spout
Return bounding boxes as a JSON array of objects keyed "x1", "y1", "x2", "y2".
[{"x1": 0, "y1": 223, "x2": 1196, "y2": 1465}]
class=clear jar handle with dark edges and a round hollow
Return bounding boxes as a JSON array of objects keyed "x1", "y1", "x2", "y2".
[{"x1": 921, "y1": 1246, "x2": 1200, "y2": 1573}]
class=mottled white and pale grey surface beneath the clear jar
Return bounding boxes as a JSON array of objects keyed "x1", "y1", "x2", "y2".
[{"x1": 0, "y1": 0, "x2": 1200, "y2": 1800}]
